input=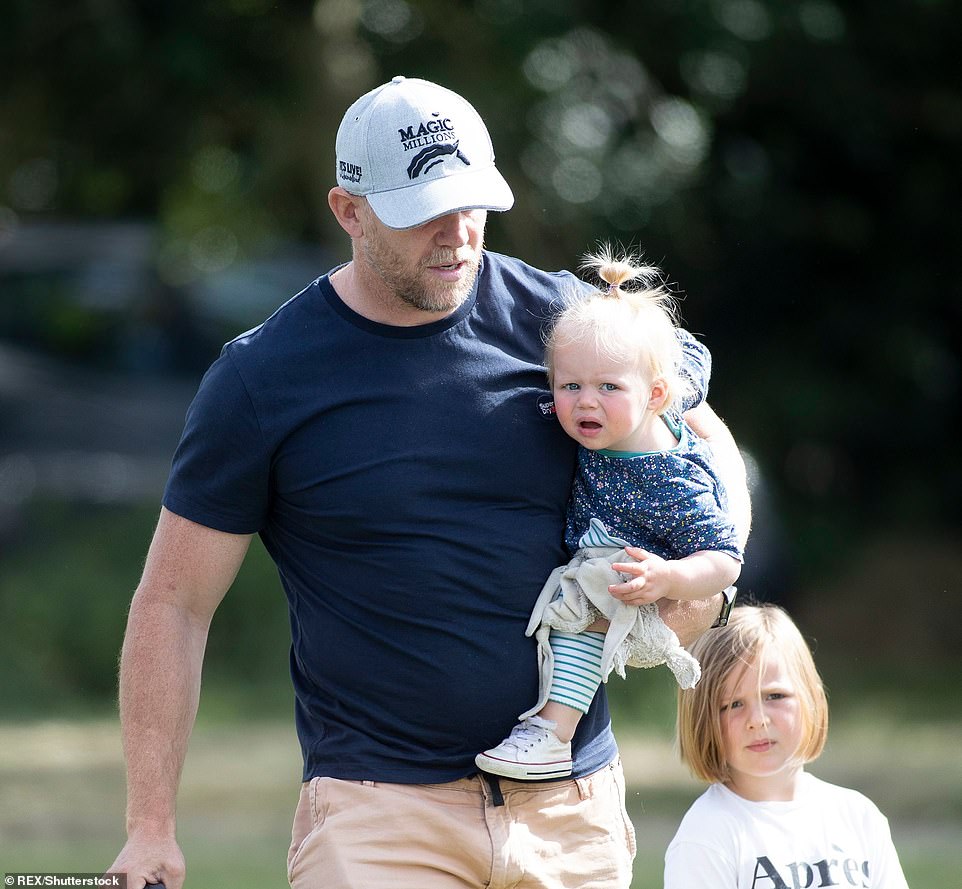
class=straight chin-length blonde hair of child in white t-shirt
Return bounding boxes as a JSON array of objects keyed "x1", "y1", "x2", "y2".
[{"x1": 677, "y1": 604, "x2": 828, "y2": 784}]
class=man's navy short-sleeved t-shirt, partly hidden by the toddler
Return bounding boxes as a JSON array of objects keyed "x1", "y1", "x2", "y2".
[{"x1": 164, "y1": 252, "x2": 616, "y2": 783}]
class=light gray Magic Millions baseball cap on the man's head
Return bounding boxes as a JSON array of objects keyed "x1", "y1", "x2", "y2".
[{"x1": 335, "y1": 76, "x2": 514, "y2": 229}]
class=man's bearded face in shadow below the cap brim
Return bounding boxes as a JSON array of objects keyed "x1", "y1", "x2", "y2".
[{"x1": 355, "y1": 204, "x2": 487, "y2": 312}]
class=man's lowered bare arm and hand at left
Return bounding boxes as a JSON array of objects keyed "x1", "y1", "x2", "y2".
[{"x1": 110, "y1": 509, "x2": 250, "y2": 889}]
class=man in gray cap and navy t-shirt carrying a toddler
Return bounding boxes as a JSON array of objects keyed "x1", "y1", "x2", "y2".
[{"x1": 112, "y1": 77, "x2": 747, "y2": 889}]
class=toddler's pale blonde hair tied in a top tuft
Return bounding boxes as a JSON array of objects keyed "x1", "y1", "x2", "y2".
[{"x1": 545, "y1": 246, "x2": 691, "y2": 413}]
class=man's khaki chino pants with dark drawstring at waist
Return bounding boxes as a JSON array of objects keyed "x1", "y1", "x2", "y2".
[{"x1": 288, "y1": 762, "x2": 635, "y2": 889}]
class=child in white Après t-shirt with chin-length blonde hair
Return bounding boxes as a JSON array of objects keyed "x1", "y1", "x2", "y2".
[{"x1": 665, "y1": 605, "x2": 907, "y2": 889}]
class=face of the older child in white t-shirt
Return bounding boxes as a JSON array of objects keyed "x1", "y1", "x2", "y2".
[{"x1": 720, "y1": 651, "x2": 804, "y2": 800}]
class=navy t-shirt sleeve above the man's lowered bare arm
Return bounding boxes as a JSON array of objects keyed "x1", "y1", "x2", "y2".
[{"x1": 163, "y1": 351, "x2": 270, "y2": 534}]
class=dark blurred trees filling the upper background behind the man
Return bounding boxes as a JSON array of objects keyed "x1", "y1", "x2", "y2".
[{"x1": 0, "y1": 0, "x2": 962, "y2": 591}]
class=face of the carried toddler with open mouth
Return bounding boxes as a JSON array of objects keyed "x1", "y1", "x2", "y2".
[{"x1": 552, "y1": 343, "x2": 657, "y2": 451}]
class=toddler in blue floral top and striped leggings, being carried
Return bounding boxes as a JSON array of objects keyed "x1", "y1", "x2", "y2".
[{"x1": 475, "y1": 250, "x2": 744, "y2": 780}]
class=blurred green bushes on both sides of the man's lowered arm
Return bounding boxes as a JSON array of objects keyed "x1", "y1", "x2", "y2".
[{"x1": 0, "y1": 501, "x2": 293, "y2": 719}]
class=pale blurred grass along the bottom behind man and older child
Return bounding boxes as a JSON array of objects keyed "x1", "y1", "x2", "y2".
[{"x1": 0, "y1": 713, "x2": 962, "y2": 889}]
